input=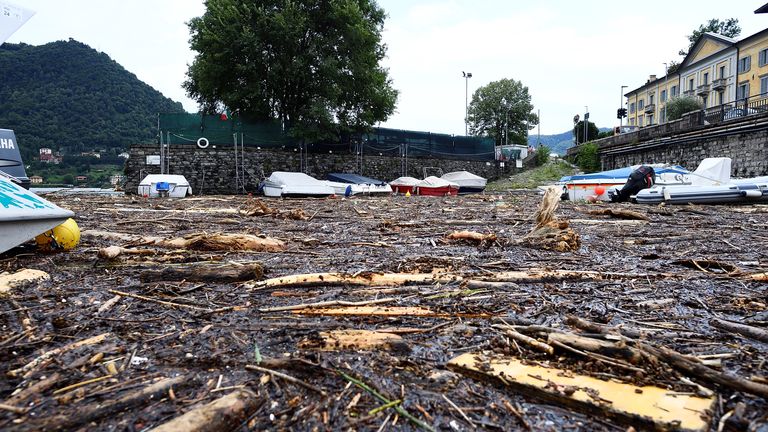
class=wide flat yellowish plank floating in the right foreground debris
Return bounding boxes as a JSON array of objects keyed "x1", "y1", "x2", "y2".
[{"x1": 448, "y1": 353, "x2": 715, "y2": 431}]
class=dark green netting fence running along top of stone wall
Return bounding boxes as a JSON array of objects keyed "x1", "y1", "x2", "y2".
[{"x1": 158, "y1": 113, "x2": 495, "y2": 160}]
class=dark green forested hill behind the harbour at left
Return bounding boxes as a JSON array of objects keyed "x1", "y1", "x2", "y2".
[{"x1": 0, "y1": 39, "x2": 183, "y2": 162}]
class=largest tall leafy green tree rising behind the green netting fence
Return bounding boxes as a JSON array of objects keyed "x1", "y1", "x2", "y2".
[{"x1": 184, "y1": 0, "x2": 397, "y2": 139}]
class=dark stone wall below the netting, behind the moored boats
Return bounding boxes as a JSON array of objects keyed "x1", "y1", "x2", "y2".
[{"x1": 125, "y1": 144, "x2": 515, "y2": 195}]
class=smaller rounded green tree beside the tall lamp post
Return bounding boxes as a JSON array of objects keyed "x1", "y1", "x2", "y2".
[{"x1": 467, "y1": 78, "x2": 539, "y2": 145}]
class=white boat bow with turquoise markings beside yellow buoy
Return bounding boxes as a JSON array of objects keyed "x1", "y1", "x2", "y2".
[{"x1": 0, "y1": 172, "x2": 74, "y2": 252}]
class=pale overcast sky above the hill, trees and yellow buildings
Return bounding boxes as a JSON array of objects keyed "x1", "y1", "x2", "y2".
[{"x1": 6, "y1": 0, "x2": 768, "y2": 134}]
